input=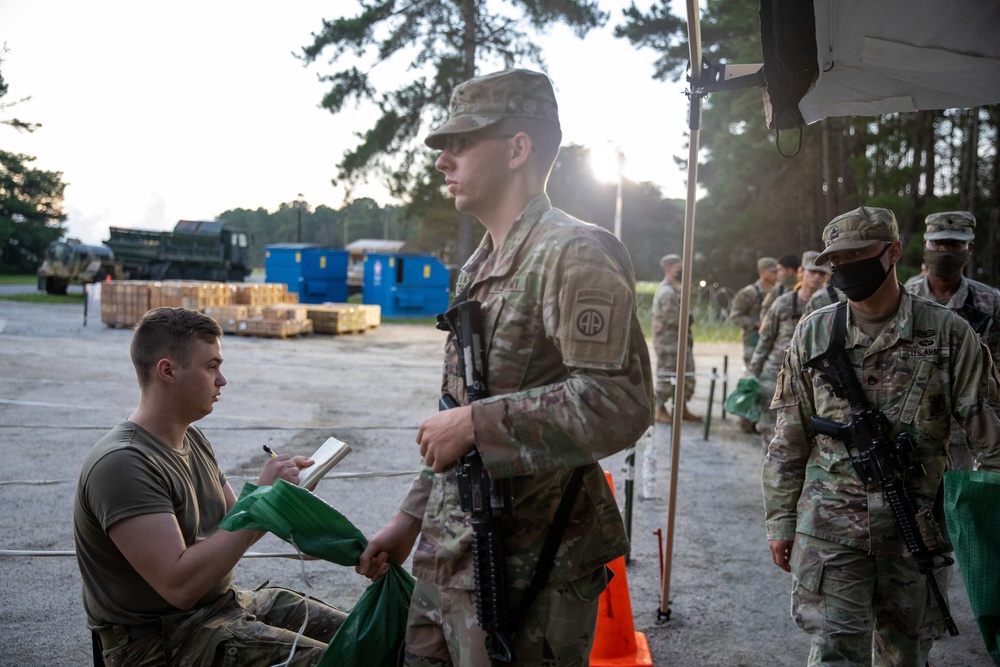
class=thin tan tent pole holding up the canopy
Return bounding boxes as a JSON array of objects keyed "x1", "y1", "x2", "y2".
[{"x1": 658, "y1": 0, "x2": 711, "y2": 620}]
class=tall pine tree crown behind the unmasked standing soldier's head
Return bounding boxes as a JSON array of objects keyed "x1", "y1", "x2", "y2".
[{"x1": 300, "y1": 0, "x2": 607, "y2": 237}]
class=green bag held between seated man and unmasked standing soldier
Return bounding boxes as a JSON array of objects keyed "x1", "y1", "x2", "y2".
[{"x1": 219, "y1": 479, "x2": 413, "y2": 667}]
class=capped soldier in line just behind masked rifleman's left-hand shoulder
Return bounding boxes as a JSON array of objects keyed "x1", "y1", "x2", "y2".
[{"x1": 747, "y1": 250, "x2": 830, "y2": 451}]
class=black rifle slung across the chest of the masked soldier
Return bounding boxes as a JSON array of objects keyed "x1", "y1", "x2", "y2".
[{"x1": 804, "y1": 303, "x2": 958, "y2": 637}]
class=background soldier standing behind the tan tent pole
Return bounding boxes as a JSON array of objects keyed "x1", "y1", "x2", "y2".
[{"x1": 652, "y1": 255, "x2": 701, "y2": 424}]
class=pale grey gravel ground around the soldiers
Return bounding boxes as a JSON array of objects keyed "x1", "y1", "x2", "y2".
[{"x1": 0, "y1": 293, "x2": 991, "y2": 667}]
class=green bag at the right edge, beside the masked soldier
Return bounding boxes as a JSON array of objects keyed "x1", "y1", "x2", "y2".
[{"x1": 944, "y1": 470, "x2": 1000, "y2": 665}]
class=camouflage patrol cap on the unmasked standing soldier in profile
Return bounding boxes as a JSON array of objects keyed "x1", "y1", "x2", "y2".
[{"x1": 424, "y1": 69, "x2": 559, "y2": 149}]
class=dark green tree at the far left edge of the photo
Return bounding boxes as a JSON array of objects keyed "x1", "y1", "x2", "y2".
[{"x1": 0, "y1": 52, "x2": 66, "y2": 273}]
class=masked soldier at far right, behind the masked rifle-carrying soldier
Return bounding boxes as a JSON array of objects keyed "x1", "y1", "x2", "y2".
[{"x1": 906, "y1": 211, "x2": 1000, "y2": 470}]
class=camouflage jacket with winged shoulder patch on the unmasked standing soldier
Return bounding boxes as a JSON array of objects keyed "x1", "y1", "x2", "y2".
[{"x1": 400, "y1": 194, "x2": 653, "y2": 589}]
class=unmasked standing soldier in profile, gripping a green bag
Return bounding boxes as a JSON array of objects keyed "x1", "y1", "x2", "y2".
[{"x1": 358, "y1": 70, "x2": 653, "y2": 665}]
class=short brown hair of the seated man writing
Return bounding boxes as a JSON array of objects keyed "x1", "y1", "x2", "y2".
[{"x1": 129, "y1": 308, "x2": 222, "y2": 388}]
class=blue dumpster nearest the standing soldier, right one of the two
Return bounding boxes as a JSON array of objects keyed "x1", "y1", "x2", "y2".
[{"x1": 363, "y1": 253, "x2": 449, "y2": 317}]
